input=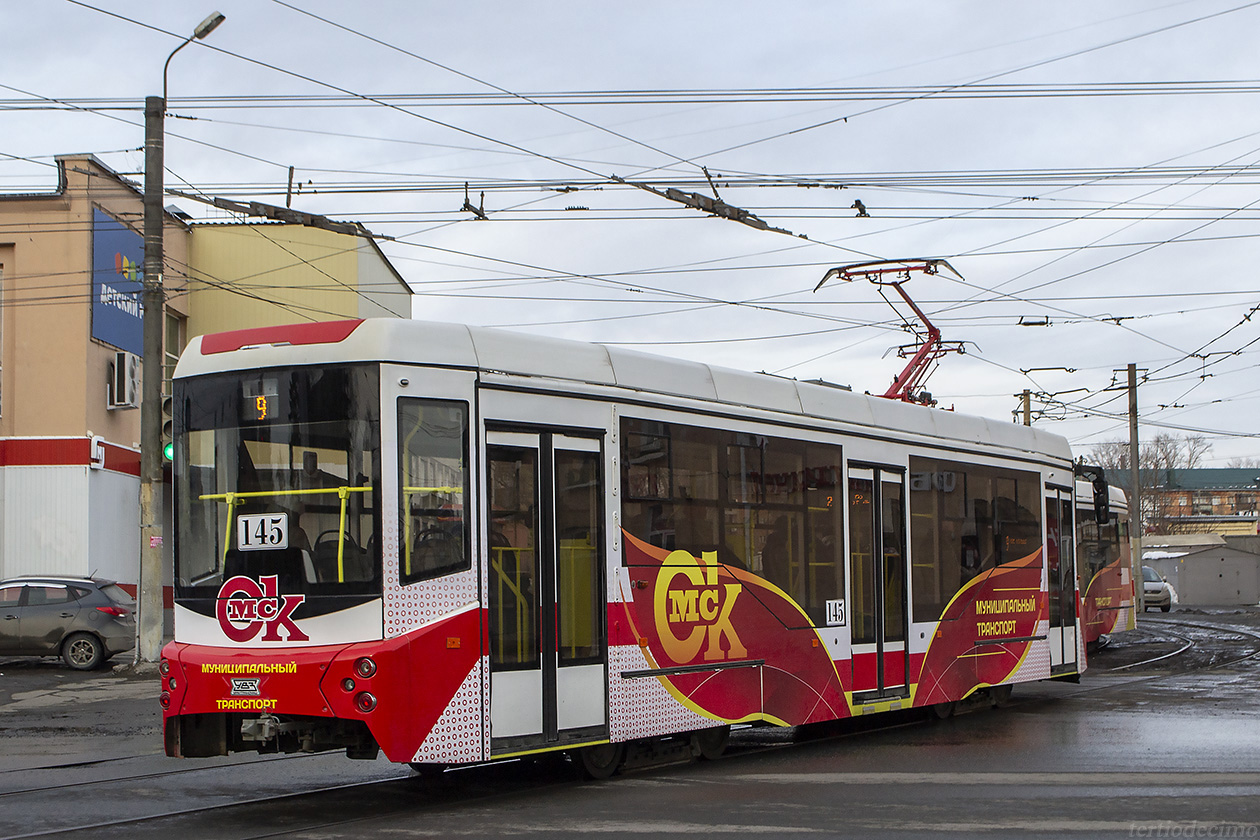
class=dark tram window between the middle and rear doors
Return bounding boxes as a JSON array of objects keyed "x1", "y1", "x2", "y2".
[{"x1": 910, "y1": 457, "x2": 1041, "y2": 621}]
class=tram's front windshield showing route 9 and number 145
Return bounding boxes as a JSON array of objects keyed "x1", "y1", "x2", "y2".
[{"x1": 174, "y1": 366, "x2": 381, "y2": 598}]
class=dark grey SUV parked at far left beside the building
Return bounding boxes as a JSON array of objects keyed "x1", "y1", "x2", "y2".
[{"x1": 0, "y1": 576, "x2": 136, "y2": 671}]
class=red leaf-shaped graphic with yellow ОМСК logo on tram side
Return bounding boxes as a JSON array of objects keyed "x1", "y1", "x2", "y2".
[{"x1": 622, "y1": 531, "x2": 848, "y2": 725}]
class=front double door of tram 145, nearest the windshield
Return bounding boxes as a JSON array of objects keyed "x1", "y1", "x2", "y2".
[{"x1": 486, "y1": 431, "x2": 607, "y2": 756}]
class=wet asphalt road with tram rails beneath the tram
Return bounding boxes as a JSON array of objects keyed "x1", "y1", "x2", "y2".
[{"x1": 0, "y1": 611, "x2": 1260, "y2": 840}]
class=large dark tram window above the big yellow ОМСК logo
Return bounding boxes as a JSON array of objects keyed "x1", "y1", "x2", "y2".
[{"x1": 621, "y1": 418, "x2": 845, "y2": 623}]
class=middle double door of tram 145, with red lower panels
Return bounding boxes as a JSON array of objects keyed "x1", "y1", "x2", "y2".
[{"x1": 849, "y1": 465, "x2": 910, "y2": 701}]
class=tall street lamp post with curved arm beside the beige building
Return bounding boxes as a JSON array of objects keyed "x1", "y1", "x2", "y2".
[{"x1": 136, "y1": 11, "x2": 224, "y2": 662}]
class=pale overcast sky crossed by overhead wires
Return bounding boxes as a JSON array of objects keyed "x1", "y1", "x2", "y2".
[{"x1": 7, "y1": 0, "x2": 1260, "y2": 466}]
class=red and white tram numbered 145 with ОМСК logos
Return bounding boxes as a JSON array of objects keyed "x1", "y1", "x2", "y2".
[{"x1": 160, "y1": 320, "x2": 1105, "y2": 777}]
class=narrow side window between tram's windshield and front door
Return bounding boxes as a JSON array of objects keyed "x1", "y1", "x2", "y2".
[{"x1": 398, "y1": 399, "x2": 470, "y2": 583}]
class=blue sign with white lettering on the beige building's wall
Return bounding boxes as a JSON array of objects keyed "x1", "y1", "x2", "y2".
[{"x1": 92, "y1": 208, "x2": 145, "y2": 356}]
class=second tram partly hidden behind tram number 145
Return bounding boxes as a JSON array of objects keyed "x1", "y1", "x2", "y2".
[{"x1": 1076, "y1": 480, "x2": 1138, "y2": 650}]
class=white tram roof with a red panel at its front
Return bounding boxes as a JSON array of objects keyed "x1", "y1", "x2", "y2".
[{"x1": 175, "y1": 319, "x2": 1072, "y2": 461}]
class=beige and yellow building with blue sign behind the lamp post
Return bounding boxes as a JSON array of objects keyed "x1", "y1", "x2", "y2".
[{"x1": 0, "y1": 155, "x2": 411, "y2": 594}]
